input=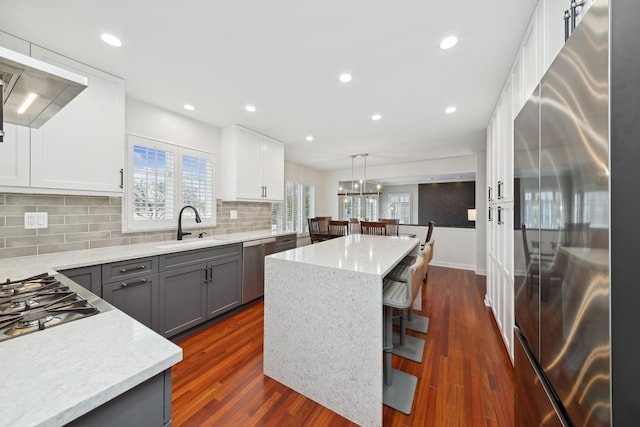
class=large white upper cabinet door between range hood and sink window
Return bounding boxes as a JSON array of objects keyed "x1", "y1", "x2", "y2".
[{"x1": 31, "y1": 46, "x2": 124, "y2": 194}]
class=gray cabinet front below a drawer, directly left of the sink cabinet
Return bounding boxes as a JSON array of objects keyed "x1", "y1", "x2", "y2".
[{"x1": 102, "y1": 274, "x2": 159, "y2": 332}]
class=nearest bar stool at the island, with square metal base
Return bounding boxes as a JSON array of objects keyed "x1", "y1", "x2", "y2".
[{"x1": 382, "y1": 254, "x2": 426, "y2": 415}]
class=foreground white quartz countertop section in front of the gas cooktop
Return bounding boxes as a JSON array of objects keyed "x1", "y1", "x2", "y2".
[{"x1": 0, "y1": 309, "x2": 182, "y2": 426}]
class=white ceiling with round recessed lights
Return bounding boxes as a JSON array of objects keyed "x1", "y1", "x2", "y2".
[{"x1": 0, "y1": 0, "x2": 536, "y2": 170}]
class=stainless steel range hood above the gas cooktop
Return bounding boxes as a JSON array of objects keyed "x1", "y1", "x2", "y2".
[{"x1": 0, "y1": 46, "x2": 88, "y2": 141}]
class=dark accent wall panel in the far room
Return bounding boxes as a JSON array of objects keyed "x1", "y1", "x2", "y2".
[{"x1": 418, "y1": 181, "x2": 476, "y2": 228}]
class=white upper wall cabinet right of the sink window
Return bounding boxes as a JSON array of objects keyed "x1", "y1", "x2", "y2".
[{"x1": 218, "y1": 125, "x2": 284, "y2": 201}]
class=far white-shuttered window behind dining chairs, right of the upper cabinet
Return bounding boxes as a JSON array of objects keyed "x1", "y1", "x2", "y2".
[{"x1": 271, "y1": 181, "x2": 315, "y2": 233}]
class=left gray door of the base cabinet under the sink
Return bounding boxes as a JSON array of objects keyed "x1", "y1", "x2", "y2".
[{"x1": 160, "y1": 264, "x2": 208, "y2": 337}]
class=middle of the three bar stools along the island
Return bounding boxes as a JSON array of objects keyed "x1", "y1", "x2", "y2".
[{"x1": 384, "y1": 247, "x2": 431, "y2": 363}]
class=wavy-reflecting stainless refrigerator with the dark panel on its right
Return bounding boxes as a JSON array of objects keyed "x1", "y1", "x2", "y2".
[{"x1": 514, "y1": 0, "x2": 640, "y2": 427}]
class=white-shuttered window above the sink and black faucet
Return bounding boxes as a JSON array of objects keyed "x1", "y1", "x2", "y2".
[{"x1": 122, "y1": 135, "x2": 216, "y2": 231}]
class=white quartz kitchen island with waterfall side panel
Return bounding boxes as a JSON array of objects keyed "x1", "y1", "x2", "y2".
[{"x1": 264, "y1": 234, "x2": 420, "y2": 426}]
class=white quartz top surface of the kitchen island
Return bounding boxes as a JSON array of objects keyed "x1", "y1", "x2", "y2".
[{"x1": 269, "y1": 234, "x2": 420, "y2": 276}]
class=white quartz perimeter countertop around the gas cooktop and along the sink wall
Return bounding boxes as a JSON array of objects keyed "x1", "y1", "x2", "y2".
[{"x1": 0, "y1": 230, "x2": 291, "y2": 426}]
